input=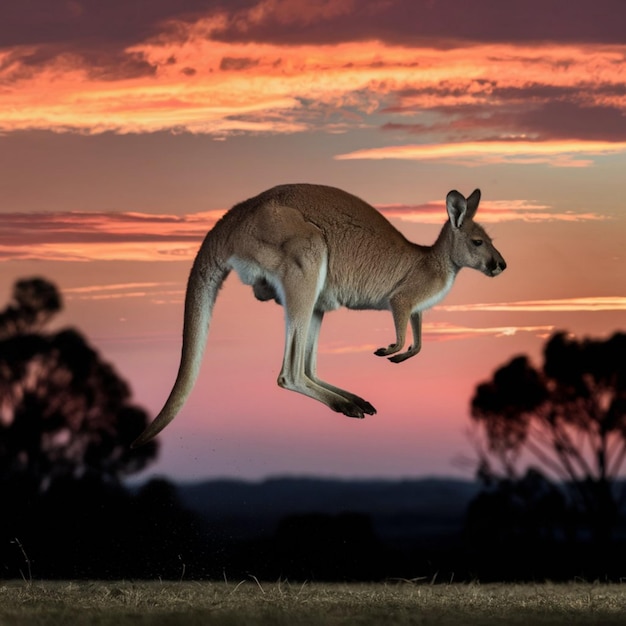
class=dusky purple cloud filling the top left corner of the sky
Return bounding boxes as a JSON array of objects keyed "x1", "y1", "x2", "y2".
[{"x1": 0, "y1": 0, "x2": 252, "y2": 81}]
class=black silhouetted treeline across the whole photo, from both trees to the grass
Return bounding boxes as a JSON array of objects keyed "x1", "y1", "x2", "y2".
[{"x1": 0, "y1": 278, "x2": 626, "y2": 582}]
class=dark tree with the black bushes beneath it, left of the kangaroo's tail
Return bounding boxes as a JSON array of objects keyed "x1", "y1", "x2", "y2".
[{"x1": 0, "y1": 278, "x2": 202, "y2": 578}]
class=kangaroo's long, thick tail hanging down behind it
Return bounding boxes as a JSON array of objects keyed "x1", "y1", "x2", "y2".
[{"x1": 131, "y1": 237, "x2": 230, "y2": 448}]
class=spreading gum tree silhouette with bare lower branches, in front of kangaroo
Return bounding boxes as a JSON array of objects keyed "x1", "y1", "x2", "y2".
[{"x1": 471, "y1": 332, "x2": 626, "y2": 560}]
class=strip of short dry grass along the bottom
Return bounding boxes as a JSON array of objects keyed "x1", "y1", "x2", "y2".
[{"x1": 0, "y1": 580, "x2": 626, "y2": 626}]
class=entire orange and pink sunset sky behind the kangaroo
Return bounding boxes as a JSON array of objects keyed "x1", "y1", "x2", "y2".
[{"x1": 0, "y1": 0, "x2": 626, "y2": 479}]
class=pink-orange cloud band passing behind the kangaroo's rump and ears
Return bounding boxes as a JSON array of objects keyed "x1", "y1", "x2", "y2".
[{"x1": 0, "y1": 195, "x2": 606, "y2": 261}]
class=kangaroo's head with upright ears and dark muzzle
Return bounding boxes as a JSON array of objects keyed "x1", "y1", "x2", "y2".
[{"x1": 446, "y1": 189, "x2": 506, "y2": 276}]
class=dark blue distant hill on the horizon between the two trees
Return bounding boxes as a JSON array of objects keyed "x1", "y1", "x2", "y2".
[{"x1": 173, "y1": 478, "x2": 479, "y2": 543}]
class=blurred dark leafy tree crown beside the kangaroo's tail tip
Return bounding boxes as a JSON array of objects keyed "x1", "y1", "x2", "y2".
[{"x1": 0, "y1": 278, "x2": 157, "y2": 491}]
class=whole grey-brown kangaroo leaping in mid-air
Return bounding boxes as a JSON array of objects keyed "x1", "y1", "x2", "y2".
[{"x1": 133, "y1": 184, "x2": 506, "y2": 446}]
